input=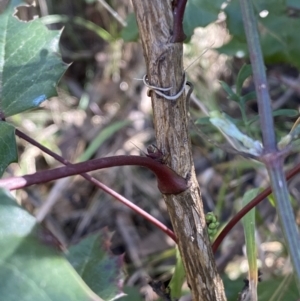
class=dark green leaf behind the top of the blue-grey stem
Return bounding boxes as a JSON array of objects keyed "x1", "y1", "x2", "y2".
[{"x1": 218, "y1": 0, "x2": 300, "y2": 68}]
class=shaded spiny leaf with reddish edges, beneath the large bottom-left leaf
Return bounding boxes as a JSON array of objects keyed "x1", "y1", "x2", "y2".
[{"x1": 67, "y1": 231, "x2": 124, "y2": 301}]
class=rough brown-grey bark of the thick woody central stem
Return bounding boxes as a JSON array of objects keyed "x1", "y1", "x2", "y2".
[{"x1": 132, "y1": 0, "x2": 226, "y2": 301}]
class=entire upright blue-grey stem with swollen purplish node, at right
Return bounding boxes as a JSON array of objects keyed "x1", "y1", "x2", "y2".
[{"x1": 240, "y1": 0, "x2": 300, "y2": 288}]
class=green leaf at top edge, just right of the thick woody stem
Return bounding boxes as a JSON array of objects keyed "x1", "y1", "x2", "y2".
[{"x1": 183, "y1": 0, "x2": 224, "y2": 38}]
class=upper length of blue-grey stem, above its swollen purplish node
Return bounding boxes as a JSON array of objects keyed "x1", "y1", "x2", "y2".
[{"x1": 240, "y1": 0, "x2": 277, "y2": 153}]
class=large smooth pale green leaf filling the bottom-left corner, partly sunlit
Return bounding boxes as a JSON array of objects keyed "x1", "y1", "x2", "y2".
[{"x1": 0, "y1": 189, "x2": 102, "y2": 301}]
